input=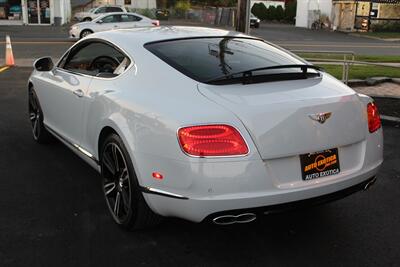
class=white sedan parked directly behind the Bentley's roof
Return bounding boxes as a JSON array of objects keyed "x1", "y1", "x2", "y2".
[{"x1": 69, "y1": 12, "x2": 160, "y2": 39}]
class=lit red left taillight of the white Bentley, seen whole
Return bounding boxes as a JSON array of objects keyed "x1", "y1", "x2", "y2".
[{"x1": 178, "y1": 124, "x2": 249, "y2": 157}]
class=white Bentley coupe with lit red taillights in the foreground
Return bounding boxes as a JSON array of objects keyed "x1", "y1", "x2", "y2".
[{"x1": 28, "y1": 27, "x2": 383, "y2": 229}]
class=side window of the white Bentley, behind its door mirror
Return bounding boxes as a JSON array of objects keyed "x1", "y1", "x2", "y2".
[{"x1": 61, "y1": 42, "x2": 130, "y2": 77}]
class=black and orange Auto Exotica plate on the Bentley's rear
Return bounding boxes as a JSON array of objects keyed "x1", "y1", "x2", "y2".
[{"x1": 300, "y1": 148, "x2": 340, "y2": 181}]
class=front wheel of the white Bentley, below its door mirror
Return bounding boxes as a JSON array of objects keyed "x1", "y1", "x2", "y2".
[{"x1": 28, "y1": 88, "x2": 53, "y2": 144}]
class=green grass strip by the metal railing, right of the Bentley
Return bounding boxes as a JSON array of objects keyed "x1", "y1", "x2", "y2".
[{"x1": 319, "y1": 64, "x2": 400, "y2": 80}]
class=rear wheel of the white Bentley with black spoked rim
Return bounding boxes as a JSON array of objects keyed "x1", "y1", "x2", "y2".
[{"x1": 100, "y1": 134, "x2": 161, "y2": 230}]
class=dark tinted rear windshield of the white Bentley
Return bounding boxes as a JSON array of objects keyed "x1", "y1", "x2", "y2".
[{"x1": 145, "y1": 37, "x2": 305, "y2": 82}]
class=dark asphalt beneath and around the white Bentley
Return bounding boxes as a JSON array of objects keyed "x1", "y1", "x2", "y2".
[{"x1": 0, "y1": 68, "x2": 400, "y2": 266}]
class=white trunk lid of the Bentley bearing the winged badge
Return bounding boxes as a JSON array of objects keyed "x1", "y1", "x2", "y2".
[{"x1": 198, "y1": 75, "x2": 366, "y2": 159}]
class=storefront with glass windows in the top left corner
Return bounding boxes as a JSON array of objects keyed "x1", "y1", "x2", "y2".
[{"x1": 0, "y1": 0, "x2": 71, "y2": 25}]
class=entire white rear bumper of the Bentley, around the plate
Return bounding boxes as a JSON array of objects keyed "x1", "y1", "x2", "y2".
[{"x1": 137, "y1": 126, "x2": 383, "y2": 222}]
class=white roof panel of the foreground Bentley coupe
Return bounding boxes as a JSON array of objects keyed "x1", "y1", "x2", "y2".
[{"x1": 88, "y1": 26, "x2": 253, "y2": 48}]
